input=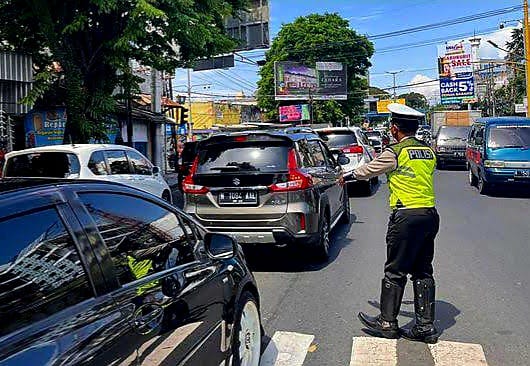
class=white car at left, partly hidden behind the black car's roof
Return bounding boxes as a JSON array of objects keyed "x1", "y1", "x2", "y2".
[{"x1": 3, "y1": 144, "x2": 171, "y2": 202}]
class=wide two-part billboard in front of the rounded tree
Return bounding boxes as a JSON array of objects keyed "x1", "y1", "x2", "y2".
[{"x1": 274, "y1": 61, "x2": 348, "y2": 100}]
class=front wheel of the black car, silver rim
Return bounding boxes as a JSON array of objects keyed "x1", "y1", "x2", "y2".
[{"x1": 231, "y1": 291, "x2": 261, "y2": 366}]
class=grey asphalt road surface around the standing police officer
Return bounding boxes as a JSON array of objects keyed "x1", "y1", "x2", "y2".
[{"x1": 249, "y1": 171, "x2": 530, "y2": 366}]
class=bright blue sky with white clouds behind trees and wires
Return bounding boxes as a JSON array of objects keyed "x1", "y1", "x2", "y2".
[{"x1": 175, "y1": 0, "x2": 523, "y2": 103}]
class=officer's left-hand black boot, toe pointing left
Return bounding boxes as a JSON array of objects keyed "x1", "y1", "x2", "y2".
[{"x1": 358, "y1": 279, "x2": 405, "y2": 339}]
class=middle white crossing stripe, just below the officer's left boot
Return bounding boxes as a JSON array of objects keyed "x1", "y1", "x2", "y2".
[{"x1": 350, "y1": 337, "x2": 397, "y2": 366}]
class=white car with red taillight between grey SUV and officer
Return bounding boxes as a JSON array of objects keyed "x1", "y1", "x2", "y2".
[{"x1": 315, "y1": 127, "x2": 378, "y2": 194}]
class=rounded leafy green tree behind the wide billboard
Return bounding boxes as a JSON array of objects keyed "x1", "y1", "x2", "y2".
[{"x1": 257, "y1": 13, "x2": 374, "y2": 124}]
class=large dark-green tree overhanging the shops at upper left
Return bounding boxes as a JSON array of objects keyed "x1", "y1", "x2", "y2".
[{"x1": 0, "y1": 0, "x2": 245, "y2": 142}]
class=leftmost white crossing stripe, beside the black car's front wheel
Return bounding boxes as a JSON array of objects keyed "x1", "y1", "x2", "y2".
[{"x1": 260, "y1": 332, "x2": 315, "y2": 366}]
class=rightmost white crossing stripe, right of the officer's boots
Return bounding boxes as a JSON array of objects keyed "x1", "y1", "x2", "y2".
[{"x1": 429, "y1": 341, "x2": 488, "y2": 366}]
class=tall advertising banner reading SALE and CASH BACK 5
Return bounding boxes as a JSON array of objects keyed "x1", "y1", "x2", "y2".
[{"x1": 438, "y1": 42, "x2": 475, "y2": 104}]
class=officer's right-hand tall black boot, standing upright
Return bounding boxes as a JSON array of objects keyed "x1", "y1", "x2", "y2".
[{"x1": 401, "y1": 278, "x2": 439, "y2": 343}]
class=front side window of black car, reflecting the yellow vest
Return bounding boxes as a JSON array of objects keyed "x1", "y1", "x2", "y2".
[{"x1": 80, "y1": 193, "x2": 195, "y2": 287}]
